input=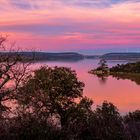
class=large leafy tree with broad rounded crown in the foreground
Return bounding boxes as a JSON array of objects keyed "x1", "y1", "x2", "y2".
[{"x1": 19, "y1": 67, "x2": 84, "y2": 127}]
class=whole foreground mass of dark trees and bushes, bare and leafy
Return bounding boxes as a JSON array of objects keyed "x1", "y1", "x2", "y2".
[{"x1": 0, "y1": 38, "x2": 140, "y2": 140}]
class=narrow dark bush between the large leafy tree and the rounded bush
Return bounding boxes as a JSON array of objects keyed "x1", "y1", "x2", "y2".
[{"x1": 62, "y1": 97, "x2": 93, "y2": 140}]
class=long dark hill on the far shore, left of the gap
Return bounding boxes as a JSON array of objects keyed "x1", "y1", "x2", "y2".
[{"x1": 0, "y1": 52, "x2": 99, "y2": 61}]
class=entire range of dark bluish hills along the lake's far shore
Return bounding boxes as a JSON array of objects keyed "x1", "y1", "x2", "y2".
[{"x1": 0, "y1": 51, "x2": 140, "y2": 61}]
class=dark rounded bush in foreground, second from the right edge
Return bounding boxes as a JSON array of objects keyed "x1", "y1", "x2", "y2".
[{"x1": 89, "y1": 101, "x2": 124, "y2": 140}]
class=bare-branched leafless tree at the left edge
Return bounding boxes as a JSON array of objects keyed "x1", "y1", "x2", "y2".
[{"x1": 0, "y1": 36, "x2": 29, "y2": 114}]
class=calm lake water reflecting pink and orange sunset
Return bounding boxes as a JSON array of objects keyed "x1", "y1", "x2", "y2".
[{"x1": 32, "y1": 60, "x2": 140, "y2": 113}]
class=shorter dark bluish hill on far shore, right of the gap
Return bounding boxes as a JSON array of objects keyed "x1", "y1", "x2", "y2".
[{"x1": 101, "y1": 53, "x2": 140, "y2": 60}]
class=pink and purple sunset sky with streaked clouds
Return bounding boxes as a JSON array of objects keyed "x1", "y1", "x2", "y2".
[{"x1": 0, "y1": 0, "x2": 140, "y2": 52}]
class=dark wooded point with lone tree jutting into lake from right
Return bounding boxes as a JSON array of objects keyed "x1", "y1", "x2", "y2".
[{"x1": 89, "y1": 59, "x2": 140, "y2": 85}]
